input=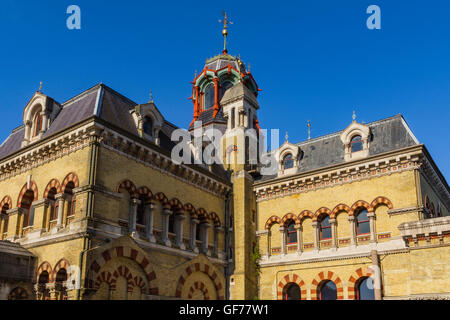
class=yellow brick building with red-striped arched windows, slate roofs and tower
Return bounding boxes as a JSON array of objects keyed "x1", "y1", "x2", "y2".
[{"x1": 0, "y1": 50, "x2": 450, "y2": 299}]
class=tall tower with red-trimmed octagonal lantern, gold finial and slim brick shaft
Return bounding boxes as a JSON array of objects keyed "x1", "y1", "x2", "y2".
[{"x1": 189, "y1": 14, "x2": 262, "y2": 300}]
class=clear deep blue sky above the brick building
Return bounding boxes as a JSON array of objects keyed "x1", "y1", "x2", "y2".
[{"x1": 0, "y1": 0, "x2": 450, "y2": 179}]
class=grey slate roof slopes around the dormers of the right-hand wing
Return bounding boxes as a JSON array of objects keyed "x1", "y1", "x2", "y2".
[{"x1": 259, "y1": 115, "x2": 419, "y2": 181}]
